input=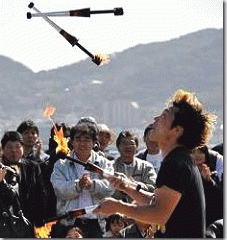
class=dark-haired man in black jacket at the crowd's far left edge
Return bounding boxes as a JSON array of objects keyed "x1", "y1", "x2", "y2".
[{"x1": 1, "y1": 131, "x2": 47, "y2": 225}]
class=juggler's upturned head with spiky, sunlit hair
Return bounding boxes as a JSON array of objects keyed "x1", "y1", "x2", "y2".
[{"x1": 149, "y1": 89, "x2": 216, "y2": 150}]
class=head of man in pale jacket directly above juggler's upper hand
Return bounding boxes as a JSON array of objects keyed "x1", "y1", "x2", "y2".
[{"x1": 116, "y1": 130, "x2": 139, "y2": 164}]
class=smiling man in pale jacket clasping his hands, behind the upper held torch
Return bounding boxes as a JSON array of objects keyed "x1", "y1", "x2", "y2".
[{"x1": 51, "y1": 121, "x2": 113, "y2": 238}]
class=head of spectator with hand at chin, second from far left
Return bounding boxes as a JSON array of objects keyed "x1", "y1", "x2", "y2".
[{"x1": 17, "y1": 119, "x2": 40, "y2": 153}]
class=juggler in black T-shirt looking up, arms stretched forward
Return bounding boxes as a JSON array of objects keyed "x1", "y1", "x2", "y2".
[{"x1": 94, "y1": 90, "x2": 216, "y2": 238}]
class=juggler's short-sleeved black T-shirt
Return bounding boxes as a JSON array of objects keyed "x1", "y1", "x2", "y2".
[{"x1": 156, "y1": 147, "x2": 205, "y2": 238}]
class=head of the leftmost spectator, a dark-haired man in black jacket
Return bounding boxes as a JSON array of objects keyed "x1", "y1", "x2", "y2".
[{"x1": 1, "y1": 131, "x2": 24, "y2": 163}]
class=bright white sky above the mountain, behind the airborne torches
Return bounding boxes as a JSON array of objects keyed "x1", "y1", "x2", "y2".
[{"x1": 0, "y1": 0, "x2": 223, "y2": 72}]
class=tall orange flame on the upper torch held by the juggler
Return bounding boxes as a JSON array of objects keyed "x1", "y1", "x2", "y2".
[{"x1": 54, "y1": 124, "x2": 70, "y2": 156}]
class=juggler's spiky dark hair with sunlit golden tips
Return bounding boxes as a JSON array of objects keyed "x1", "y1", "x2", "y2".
[{"x1": 169, "y1": 89, "x2": 216, "y2": 150}]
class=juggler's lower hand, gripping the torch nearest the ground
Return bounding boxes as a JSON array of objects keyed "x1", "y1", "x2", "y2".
[{"x1": 93, "y1": 198, "x2": 123, "y2": 216}]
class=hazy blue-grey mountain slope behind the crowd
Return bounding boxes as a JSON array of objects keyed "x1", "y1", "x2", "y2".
[{"x1": 0, "y1": 29, "x2": 223, "y2": 144}]
